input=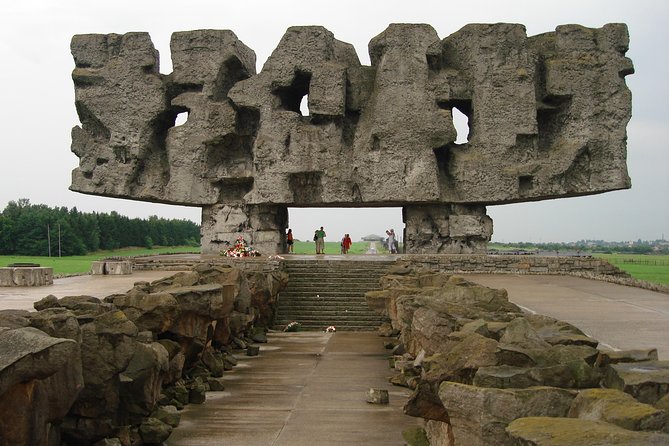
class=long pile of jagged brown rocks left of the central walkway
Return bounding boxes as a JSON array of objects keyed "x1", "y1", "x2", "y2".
[{"x1": 0, "y1": 264, "x2": 288, "y2": 446}]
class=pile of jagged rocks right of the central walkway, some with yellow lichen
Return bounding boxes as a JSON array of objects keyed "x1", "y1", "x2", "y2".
[{"x1": 366, "y1": 263, "x2": 669, "y2": 446}]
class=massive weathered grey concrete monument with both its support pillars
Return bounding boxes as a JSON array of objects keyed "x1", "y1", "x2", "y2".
[{"x1": 71, "y1": 24, "x2": 634, "y2": 254}]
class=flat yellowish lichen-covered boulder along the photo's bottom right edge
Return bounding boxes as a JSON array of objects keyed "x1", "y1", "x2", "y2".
[{"x1": 505, "y1": 416, "x2": 669, "y2": 446}]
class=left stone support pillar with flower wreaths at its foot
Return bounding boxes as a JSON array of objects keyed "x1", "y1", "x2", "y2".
[{"x1": 201, "y1": 204, "x2": 288, "y2": 256}]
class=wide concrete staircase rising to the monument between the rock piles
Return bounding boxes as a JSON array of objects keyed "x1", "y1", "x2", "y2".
[{"x1": 275, "y1": 257, "x2": 394, "y2": 331}]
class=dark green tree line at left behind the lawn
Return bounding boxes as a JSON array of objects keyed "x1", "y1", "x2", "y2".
[{"x1": 0, "y1": 198, "x2": 200, "y2": 256}]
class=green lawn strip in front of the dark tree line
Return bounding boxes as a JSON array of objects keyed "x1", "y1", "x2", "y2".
[{"x1": 0, "y1": 246, "x2": 199, "y2": 274}]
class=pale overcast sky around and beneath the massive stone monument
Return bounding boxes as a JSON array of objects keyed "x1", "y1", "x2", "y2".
[{"x1": 0, "y1": 0, "x2": 669, "y2": 242}]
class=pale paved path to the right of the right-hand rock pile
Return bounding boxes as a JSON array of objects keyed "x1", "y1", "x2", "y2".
[{"x1": 464, "y1": 274, "x2": 669, "y2": 359}]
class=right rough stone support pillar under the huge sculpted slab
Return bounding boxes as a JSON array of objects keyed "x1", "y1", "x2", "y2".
[{"x1": 402, "y1": 204, "x2": 492, "y2": 254}]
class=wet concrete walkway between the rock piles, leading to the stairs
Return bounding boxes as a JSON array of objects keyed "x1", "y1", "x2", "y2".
[{"x1": 166, "y1": 332, "x2": 421, "y2": 446}]
